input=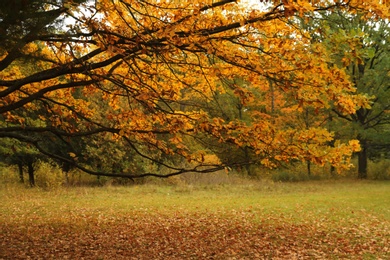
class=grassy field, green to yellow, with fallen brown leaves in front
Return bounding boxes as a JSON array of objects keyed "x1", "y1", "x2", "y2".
[{"x1": 0, "y1": 180, "x2": 390, "y2": 259}]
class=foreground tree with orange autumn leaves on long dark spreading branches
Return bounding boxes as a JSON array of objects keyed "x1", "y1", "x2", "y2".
[{"x1": 0, "y1": 0, "x2": 388, "y2": 178}]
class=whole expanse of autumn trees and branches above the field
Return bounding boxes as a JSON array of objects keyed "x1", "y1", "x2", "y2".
[{"x1": 0, "y1": 0, "x2": 390, "y2": 186}]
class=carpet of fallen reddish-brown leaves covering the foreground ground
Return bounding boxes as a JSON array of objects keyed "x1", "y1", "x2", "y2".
[{"x1": 0, "y1": 209, "x2": 390, "y2": 259}]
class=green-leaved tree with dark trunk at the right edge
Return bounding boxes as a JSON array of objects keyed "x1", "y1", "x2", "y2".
[{"x1": 298, "y1": 7, "x2": 390, "y2": 178}]
